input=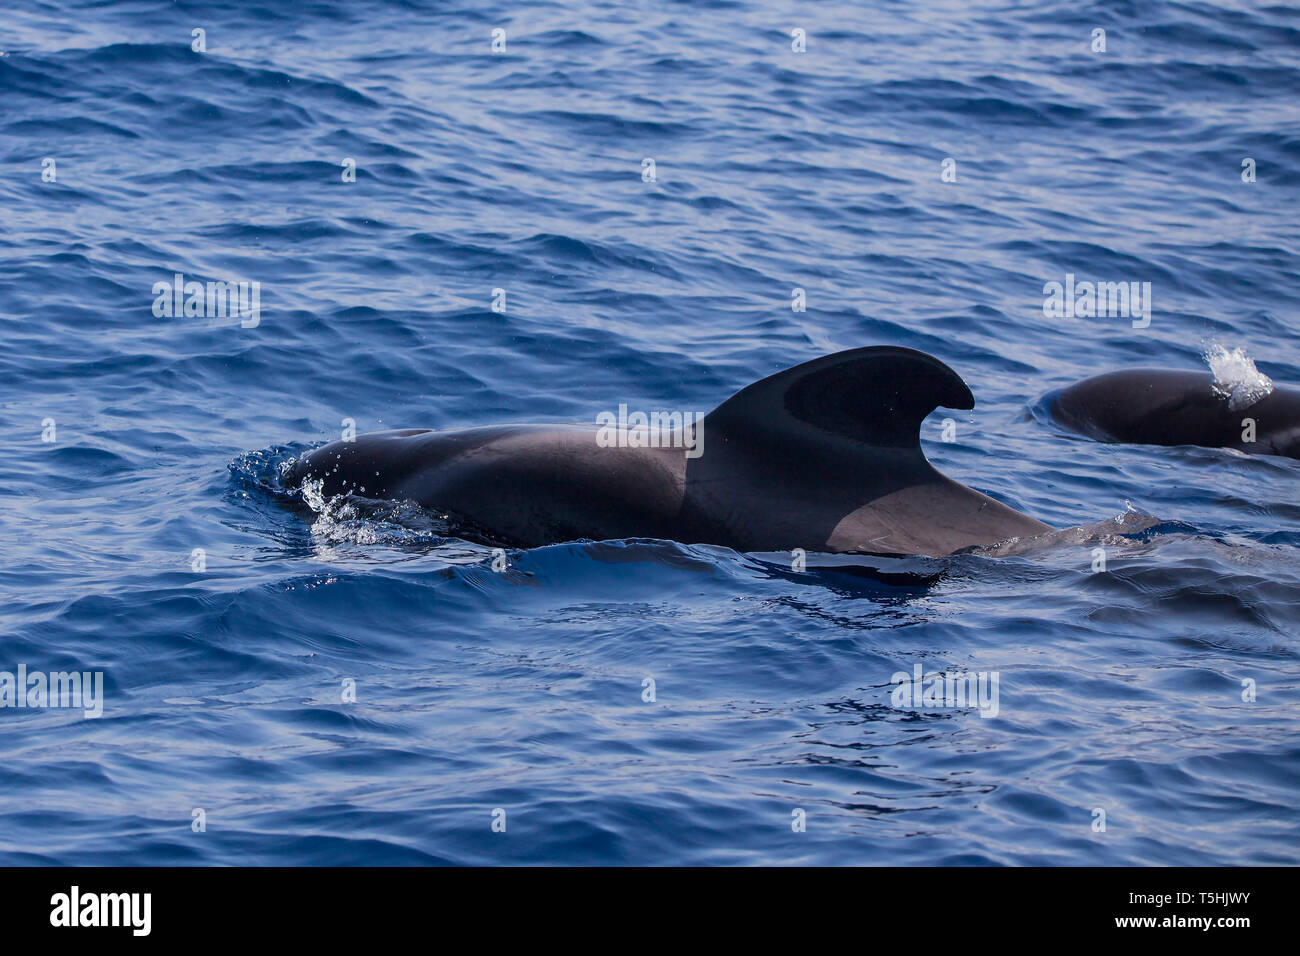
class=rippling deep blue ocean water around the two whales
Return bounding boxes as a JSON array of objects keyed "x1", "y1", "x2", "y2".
[{"x1": 0, "y1": 0, "x2": 1300, "y2": 865}]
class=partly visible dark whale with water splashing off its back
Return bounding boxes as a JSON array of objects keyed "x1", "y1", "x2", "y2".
[{"x1": 1047, "y1": 368, "x2": 1300, "y2": 458}]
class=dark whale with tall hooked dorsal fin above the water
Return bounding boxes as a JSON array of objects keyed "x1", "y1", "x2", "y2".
[{"x1": 282, "y1": 346, "x2": 1050, "y2": 557}]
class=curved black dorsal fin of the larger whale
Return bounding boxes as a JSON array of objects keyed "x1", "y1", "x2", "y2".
[{"x1": 705, "y1": 346, "x2": 975, "y2": 449}]
